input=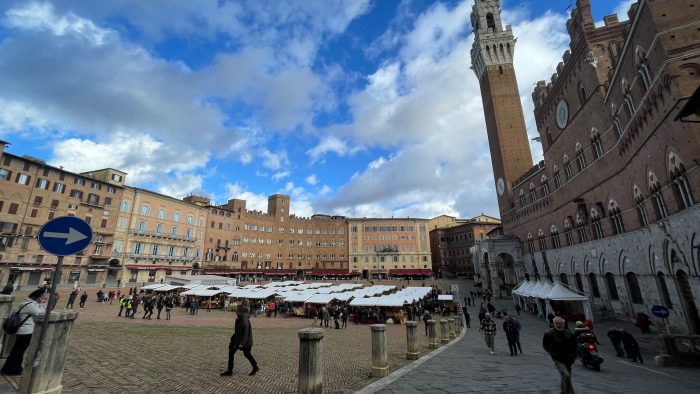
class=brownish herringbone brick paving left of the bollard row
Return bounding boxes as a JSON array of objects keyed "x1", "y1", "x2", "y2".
[{"x1": 0, "y1": 278, "x2": 448, "y2": 394}]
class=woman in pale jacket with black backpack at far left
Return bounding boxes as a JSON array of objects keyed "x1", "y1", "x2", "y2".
[{"x1": 0, "y1": 287, "x2": 48, "y2": 375}]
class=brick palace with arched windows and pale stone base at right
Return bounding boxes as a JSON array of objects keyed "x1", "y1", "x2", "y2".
[{"x1": 472, "y1": 0, "x2": 700, "y2": 334}]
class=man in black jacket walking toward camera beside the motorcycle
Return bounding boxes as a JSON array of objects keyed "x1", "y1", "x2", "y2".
[{"x1": 542, "y1": 316, "x2": 577, "y2": 394}]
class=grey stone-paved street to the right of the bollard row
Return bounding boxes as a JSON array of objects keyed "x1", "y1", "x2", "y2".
[{"x1": 364, "y1": 281, "x2": 700, "y2": 394}]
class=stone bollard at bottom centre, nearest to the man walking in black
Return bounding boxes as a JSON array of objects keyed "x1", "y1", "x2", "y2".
[{"x1": 297, "y1": 328, "x2": 324, "y2": 394}]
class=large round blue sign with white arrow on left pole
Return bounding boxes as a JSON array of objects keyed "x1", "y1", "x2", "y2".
[{"x1": 38, "y1": 216, "x2": 92, "y2": 256}]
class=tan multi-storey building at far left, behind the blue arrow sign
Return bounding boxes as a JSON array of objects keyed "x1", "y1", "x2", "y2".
[{"x1": 0, "y1": 141, "x2": 126, "y2": 286}]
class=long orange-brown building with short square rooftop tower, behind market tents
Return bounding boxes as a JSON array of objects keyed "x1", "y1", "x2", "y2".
[{"x1": 203, "y1": 194, "x2": 349, "y2": 278}]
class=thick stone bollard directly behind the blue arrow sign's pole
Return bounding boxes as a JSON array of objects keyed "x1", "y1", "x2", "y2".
[{"x1": 19, "y1": 309, "x2": 78, "y2": 394}]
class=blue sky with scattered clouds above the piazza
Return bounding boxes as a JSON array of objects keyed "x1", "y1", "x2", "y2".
[{"x1": 0, "y1": 0, "x2": 632, "y2": 218}]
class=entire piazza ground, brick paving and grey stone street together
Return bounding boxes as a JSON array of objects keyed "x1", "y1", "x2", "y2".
[{"x1": 0, "y1": 281, "x2": 700, "y2": 394}]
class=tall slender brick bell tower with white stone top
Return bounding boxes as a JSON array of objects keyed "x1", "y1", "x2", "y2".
[{"x1": 471, "y1": 0, "x2": 532, "y2": 213}]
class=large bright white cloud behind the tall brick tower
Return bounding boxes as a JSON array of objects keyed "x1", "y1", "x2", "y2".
[{"x1": 317, "y1": 1, "x2": 568, "y2": 217}]
